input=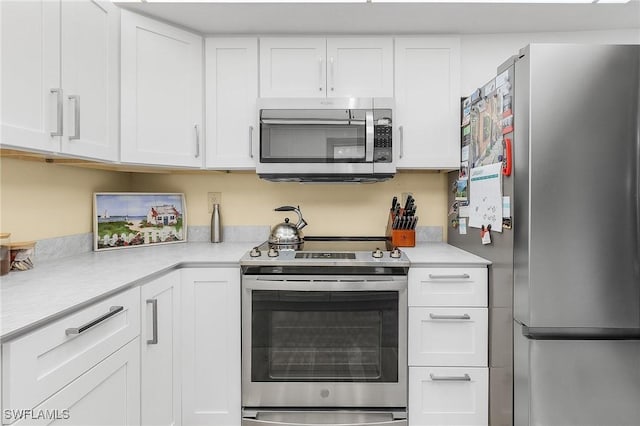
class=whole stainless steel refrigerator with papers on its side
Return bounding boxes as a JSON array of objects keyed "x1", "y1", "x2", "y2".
[{"x1": 448, "y1": 44, "x2": 640, "y2": 426}]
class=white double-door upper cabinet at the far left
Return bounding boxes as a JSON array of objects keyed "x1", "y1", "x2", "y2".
[{"x1": 0, "y1": 0, "x2": 120, "y2": 160}]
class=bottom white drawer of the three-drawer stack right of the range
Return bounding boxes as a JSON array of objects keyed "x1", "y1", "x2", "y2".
[{"x1": 409, "y1": 367, "x2": 489, "y2": 426}]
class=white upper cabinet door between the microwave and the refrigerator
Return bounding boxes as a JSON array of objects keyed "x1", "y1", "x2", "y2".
[{"x1": 394, "y1": 38, "x2": 460, "y2": 169}]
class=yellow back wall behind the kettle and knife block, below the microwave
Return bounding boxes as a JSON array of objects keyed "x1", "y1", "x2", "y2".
[{"x1": 132, "y1": 172, "x2": 447, "y2": 235}]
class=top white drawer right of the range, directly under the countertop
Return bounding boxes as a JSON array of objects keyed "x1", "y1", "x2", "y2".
[{"x1": 409, "y1": 268, "x2": 488, "y2": 306}]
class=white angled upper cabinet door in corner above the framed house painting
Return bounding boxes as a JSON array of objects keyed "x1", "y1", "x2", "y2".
[{"x1": 121, "y1": 10, "x2": 202, "y2": 167}]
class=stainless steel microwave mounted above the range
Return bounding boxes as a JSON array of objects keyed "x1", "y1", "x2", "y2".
[{"x1": 256, "y1": 98, "x2": 396, "y2": 182}]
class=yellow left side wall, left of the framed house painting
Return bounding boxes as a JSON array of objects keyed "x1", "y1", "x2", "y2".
[{"x1": 0, "y1": 158, "x2": 131, "y2": 241}]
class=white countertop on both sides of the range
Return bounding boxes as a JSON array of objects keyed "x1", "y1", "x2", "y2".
[{"x1": 0, "y1": 241, "x2": 490, "y2": 341}]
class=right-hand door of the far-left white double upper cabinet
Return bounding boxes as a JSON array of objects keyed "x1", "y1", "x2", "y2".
[{"x1": 61, "y1": 0, "x2": 120, "y2": 160}]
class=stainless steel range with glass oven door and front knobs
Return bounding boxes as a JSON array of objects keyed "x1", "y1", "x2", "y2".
[{"x1": 240, "y1": 237, "x2": 409, "y2": 426}]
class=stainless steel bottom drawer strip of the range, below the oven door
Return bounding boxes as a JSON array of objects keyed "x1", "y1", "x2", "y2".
[{"x1": 242, "y1": 411, "x2": 407, "y2": 426}]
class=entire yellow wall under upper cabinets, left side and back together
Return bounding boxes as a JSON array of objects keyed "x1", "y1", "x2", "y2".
[{"x1": 0, "y1": 158, "x2": 447, "y2": 241}]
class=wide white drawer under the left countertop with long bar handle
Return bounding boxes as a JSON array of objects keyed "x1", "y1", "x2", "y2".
[{"x1": 2, "y1": 288, "x2": 140, "y2": 416}]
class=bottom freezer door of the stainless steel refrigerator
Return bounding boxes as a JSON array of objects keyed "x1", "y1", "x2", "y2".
[{"x1": 514, "y1": 323, "x2": 640, "y2": 426}]
